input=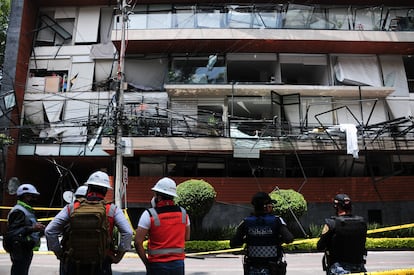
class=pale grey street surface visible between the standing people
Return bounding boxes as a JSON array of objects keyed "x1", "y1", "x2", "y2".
[{"x1": 0, "y1": 251, "x2": 414, "y2": 275}]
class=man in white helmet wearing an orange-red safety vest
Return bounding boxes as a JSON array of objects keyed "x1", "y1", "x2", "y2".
[{"x1": 135, "y1": 178, "x2": 190, "y2": 275}]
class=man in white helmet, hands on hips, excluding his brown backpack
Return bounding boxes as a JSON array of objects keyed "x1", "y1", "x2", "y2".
[{"x1": 45, "y1": 171, "x2": 132, "y2": 275}]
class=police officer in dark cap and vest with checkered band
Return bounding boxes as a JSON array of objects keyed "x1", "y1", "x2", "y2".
[{"x1": 230, "y1": 192, "x2": 293, "y2": 275}]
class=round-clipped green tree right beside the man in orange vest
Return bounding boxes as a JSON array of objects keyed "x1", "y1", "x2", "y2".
[{"x1": 175, "y1": 179, "x2": 216, "y2": 236}]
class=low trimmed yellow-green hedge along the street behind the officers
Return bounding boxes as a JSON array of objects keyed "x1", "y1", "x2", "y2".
[{"x1": 186, "y1": 238, "x2": 414, "y2": 253}]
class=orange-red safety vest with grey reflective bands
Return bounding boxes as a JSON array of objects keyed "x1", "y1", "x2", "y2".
[{"x1": 148, "y1": 205, "x2": 187, "y2": 262}]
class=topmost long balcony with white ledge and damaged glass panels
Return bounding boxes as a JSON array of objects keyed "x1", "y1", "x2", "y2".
[{"x1": 112, "y1": 4, "x2": 414, "y2": 54}]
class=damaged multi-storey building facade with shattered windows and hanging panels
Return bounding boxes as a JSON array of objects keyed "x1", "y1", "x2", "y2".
[{"x1": 1, "y1": 0, "x2": 414, "y2": 231}]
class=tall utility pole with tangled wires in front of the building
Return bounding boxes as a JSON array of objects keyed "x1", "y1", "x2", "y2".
[{"x1": 114, "y1": 0, "x2": 128, "y2": 207}]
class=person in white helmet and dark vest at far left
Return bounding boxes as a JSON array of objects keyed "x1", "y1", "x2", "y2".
[{"x1": 4, "y1": 183, "x2": 45, "y2": 275}]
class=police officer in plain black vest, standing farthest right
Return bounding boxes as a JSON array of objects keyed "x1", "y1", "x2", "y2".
[{"x1": 317, "y1": 194, "x2": 367, "y2": 275}]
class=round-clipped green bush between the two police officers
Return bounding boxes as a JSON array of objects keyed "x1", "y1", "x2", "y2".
[{"x1": 270, "y1": 189, "x2": 308, "y2": 222}]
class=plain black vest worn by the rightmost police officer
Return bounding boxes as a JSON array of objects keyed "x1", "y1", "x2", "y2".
[{"x1": 327, "y1": 216, "x2": 367, "y2": 264}]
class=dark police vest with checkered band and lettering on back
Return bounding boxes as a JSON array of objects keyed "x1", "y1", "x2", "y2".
[{"x1": 244, "y1": 215, "x2": 282, "y2": 261}]
